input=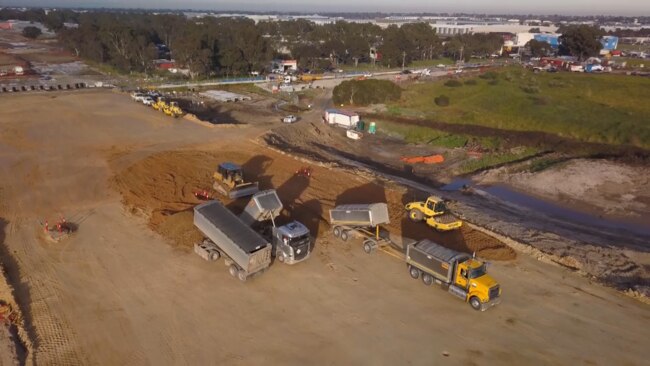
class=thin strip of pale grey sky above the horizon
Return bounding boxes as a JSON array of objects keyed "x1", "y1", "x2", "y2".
[{"x1": 5, "y1": 0, "x2": 650, "y2": 16}]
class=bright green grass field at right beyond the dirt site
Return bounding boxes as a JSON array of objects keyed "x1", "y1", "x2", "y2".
[{"x1": 387, "y1": 67, "x2": 650, "y2": 149}]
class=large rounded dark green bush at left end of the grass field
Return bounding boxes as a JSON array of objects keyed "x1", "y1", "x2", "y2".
[{"x1": 332, "y1": 79, "x2": 402, "y2": 105}]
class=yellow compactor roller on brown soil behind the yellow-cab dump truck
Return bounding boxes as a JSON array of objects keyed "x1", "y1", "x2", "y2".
[{"x1": 406, "y1": 196, "x2": 463, "y2": 231}]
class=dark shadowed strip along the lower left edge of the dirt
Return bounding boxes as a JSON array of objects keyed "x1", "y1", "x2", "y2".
[{"x1": 0, "y1": 218, "x2": 31, "y2": 365}]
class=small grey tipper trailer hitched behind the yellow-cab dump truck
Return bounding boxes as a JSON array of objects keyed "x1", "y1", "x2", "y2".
[{"x1": 330, "y1": 203, "x2": 390, "y2": 254}]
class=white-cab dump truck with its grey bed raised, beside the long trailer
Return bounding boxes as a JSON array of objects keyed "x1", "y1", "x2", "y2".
[{"x1": 240, "y1": 189, "x2": 311, "y2": 264}]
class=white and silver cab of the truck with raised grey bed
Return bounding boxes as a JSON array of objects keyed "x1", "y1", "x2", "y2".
[{"x1": 272, "y1": 221, "x2": 311, "y2": 264}]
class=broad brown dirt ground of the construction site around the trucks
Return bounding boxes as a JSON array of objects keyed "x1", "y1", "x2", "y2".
[{"x1": 0, "y1": 91, "x2": 650, "y2": 365}]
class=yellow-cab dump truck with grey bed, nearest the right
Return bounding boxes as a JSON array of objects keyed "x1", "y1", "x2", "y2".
[{"x1": 406, "y1": 239, "x2": 501, "y2": 311}]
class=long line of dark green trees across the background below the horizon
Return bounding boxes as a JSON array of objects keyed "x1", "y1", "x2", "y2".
[{"x1": 0, "y1": 9, "x2": 572, "y2": 78}]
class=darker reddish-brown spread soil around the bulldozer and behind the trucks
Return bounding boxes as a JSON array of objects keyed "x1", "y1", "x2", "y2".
[{"x1": 112, "y1": 145, "x2": 516, "y2": 260}]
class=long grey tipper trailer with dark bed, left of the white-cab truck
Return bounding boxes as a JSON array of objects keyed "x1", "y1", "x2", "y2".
[{"x1": 194, "y1": 201, "x2": 272, "y2": 281}]
